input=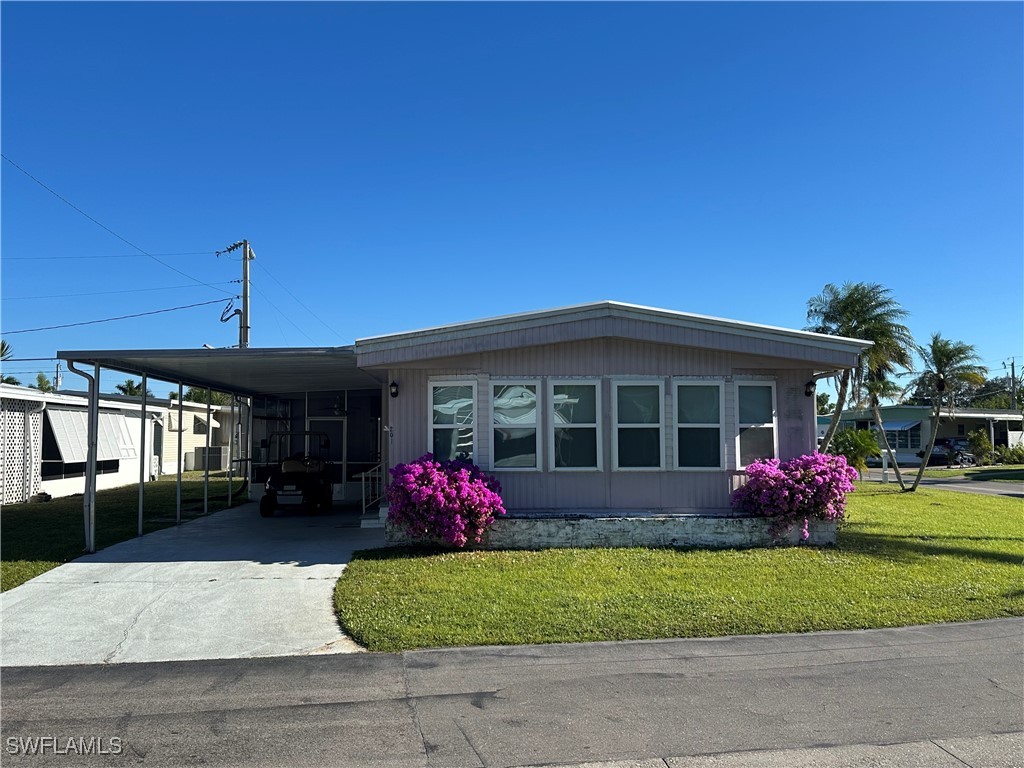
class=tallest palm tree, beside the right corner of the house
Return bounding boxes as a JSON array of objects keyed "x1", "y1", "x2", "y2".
[{"x1": 807, "y1": 283, "x2": 914, "y2": 453}]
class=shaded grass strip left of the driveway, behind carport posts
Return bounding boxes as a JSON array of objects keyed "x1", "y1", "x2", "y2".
[{"x1": 0, "y1": 479, "x2": 243, "y2": 591}]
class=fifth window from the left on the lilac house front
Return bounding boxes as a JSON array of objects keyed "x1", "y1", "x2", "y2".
[{"x1": 675, "y1": 382, "x2": 724, "y2": 469}]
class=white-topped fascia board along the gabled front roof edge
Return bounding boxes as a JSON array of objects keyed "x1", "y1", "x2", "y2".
[{"x1": 355, "y1": 301, "x2": 871, "y2": 354}]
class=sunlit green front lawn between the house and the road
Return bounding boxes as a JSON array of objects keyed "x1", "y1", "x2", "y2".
[{"x1": 336, "y1": 484, "x2": 1024, "y2": 651}]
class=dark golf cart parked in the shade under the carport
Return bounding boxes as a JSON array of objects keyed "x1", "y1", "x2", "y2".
[{"x1": 259, "y1": 432, "x2": 333, "y2": 517}]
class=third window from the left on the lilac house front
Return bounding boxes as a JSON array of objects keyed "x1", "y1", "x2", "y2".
[{"x1": 548, "y1": 381, "x2": 601, "y2": 470}]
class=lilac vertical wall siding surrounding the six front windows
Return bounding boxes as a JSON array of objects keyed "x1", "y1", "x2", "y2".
[{"x1": 380, "y1": 339, "x2": 816, "y2": 512}]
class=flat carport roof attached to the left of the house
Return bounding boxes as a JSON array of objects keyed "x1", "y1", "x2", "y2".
[{"x1": 57, "y1": 346, "x2": 381, "y2": 395}]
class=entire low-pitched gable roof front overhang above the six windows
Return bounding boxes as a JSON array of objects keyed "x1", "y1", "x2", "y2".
[{"x1": 355, "y1": 301, "x2": 871, "y2": 368}]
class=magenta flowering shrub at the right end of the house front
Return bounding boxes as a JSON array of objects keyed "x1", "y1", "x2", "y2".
[{"x1": 732, "y1": 453, "x2": 857, "y2": 541}]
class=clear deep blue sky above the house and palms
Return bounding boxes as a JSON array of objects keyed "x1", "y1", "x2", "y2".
[{"x1": 0, "y1": 2, "x2": 1024, "y2": 394}]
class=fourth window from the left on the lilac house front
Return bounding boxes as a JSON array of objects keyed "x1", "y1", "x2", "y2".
[{"x1": 611, "y1": 381, "x2": 665, "y2": 469}]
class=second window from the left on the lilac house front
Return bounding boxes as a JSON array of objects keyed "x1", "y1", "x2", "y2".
[{"x1": 490, "y1": 381, "x2": 540, "y2": 469}]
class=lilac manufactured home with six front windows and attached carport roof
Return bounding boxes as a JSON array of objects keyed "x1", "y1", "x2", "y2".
[{"x1": 58, "y1": 301, "x2": 869, "y2": 548}]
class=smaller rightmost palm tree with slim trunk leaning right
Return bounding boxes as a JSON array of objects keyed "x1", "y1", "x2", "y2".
[{"x1": 905, "y1": 334, "x2": 988, "y2": 492}]
